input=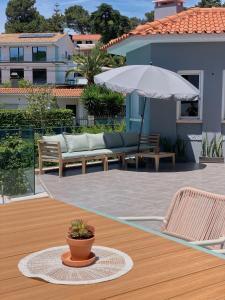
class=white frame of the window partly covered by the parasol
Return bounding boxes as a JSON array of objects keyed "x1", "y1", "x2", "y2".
[{"x1": 177, "y1": 70, "x2": 204, "y2": 121}]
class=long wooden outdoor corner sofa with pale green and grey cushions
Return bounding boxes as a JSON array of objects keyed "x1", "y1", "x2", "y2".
[{"x1": 38, "y1": 132, "x2": 160, "y2": 177}]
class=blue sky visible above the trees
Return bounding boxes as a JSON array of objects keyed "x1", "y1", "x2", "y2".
[{"x1": 0, "y1": 0, "x2": 197, "y2": 32}]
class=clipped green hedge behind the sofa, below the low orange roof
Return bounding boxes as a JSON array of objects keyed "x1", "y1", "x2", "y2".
[{"x1": 0, "y1": 109, "x2": 73, "y2": 128}]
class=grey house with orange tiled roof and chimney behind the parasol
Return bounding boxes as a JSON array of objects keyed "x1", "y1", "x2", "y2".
[{"x1": 104, "y1": 1, "x2": 225, "y2": 161}]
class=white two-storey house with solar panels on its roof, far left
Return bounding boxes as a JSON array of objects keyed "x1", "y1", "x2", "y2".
[{"x1": 0, "y1": 33, "x2": 74, "y2": 85}]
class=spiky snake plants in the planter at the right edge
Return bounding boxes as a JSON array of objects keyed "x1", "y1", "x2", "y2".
[{"x1": 199, "y1": 134, "x2": 224, "y2": 163}]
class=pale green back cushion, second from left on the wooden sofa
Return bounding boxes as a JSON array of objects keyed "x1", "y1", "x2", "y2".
[{"x1": 64, "y1": 133, "x2": 89, "y2": 152}]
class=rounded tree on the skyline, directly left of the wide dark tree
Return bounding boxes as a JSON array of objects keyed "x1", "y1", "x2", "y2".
[{"x1": 65, "y1": 5, "x2": 90, "y2": 34}]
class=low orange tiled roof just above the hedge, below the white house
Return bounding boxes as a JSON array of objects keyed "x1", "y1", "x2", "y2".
[{"x1": 0, "y1": 88, "x2": 83, "y2": 97}]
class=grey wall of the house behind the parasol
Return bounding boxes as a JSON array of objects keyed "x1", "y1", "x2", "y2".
[{"x1": 127, "y1": 42, "x2": 225, "y2": 160}]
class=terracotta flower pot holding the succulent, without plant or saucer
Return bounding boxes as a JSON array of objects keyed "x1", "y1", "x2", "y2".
[{"x1": 66, "y1": 236, "x2": 95, "y2": 261}]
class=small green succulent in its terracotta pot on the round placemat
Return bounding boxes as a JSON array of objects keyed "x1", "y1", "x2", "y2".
[{"x1": 66, "y1": 220, "x2": 95, "y2": 261}]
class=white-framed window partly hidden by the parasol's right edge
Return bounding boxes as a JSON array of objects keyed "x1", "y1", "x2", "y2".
[{"x1": 177, "y1": 71, "x2": 203, "y2": 119}]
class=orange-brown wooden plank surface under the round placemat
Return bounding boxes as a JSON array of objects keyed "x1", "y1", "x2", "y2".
[{"x1": 0, "y1": 199, "x2": 225, "y2": 300}]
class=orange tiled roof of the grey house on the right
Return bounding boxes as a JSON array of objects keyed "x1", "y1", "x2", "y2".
[{"x1": 102, "y1": 7, "x2": 225, "y2": 49}]
